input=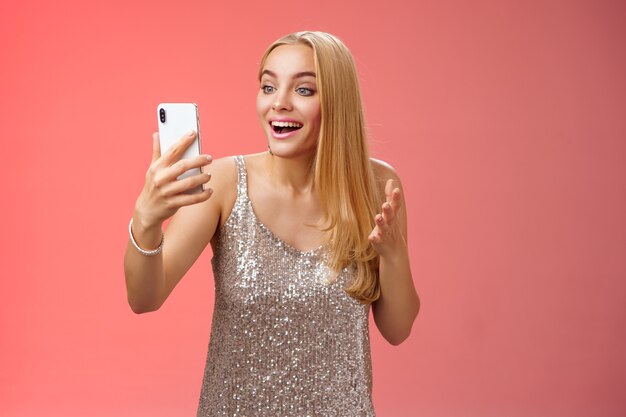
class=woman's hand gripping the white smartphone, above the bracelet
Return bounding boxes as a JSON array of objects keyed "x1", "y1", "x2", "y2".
[{"x1": 134, "y1": 131, "x2": 213, "y2": 228}]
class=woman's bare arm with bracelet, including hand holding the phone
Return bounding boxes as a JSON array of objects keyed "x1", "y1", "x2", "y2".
[{"x1": 124, "y1": 133, "x2": 220, "y2": 313}]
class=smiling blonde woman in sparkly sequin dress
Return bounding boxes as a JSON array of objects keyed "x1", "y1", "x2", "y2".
[{"x1": 125, "y1": 32, "x2": 419, "y2": 416}]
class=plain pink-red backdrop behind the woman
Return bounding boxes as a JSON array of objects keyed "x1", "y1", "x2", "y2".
[{"x1": 0, "y1": 0, "x2": 626, "y2": 417}]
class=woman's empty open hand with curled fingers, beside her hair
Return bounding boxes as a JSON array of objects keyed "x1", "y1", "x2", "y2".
[{"x1": 369, "y1": 179, "x2": 406, "y2": 256}]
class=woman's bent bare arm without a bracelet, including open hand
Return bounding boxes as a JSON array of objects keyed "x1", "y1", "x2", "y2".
[{"x1": 369, "y1": 166, "x2": 420, "y2": 345}]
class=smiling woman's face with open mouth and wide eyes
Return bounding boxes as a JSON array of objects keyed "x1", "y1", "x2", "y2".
[{"x1": 256, "y1": 44, "x2": 321, "y2": 157}]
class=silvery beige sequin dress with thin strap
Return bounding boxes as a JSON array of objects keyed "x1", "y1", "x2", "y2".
[{"x1": 198, "y1": 156, "x2": 375, "y2": 417}]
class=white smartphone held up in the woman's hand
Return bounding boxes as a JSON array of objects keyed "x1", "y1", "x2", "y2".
[{"x1": 157, "y1": 103, "x2": 204, "y2": 194}]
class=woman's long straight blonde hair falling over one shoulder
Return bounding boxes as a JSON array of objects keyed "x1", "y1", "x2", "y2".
[{"x1": 259, "y1": 32, "x2": 380, "y2": 304}]
